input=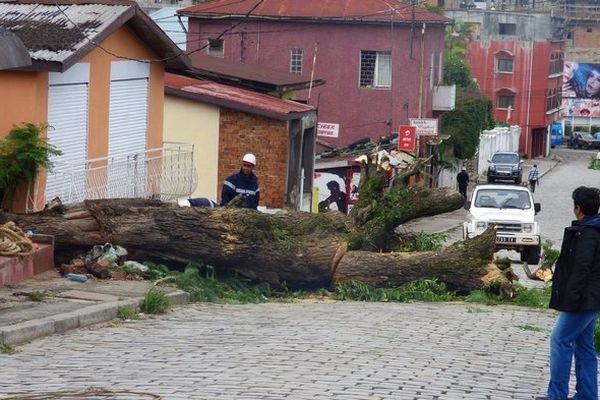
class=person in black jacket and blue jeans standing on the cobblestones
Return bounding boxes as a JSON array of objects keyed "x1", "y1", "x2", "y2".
[{"x1": 537, "y1": 186, "x2": 600, "y2": 400}]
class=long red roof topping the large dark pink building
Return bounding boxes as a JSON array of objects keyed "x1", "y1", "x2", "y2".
[{"x1": 179, "y1": 0, "x2": 451, "y2": 23}]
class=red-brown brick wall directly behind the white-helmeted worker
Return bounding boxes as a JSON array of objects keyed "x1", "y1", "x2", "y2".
[{"x1": 218, "y1": 108, "x2": 288, "y2": 208}]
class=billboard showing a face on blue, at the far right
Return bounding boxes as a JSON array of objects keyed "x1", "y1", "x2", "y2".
[{"x1": 562, "y1": 62, "x2": 600, "y2": 117}]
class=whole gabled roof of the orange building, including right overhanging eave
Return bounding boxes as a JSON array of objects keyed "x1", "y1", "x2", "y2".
[{"x1": 0, "y1": 0, "x2": 187, "y2": 71}]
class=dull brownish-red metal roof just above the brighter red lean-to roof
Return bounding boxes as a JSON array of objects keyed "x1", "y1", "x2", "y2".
[{"x1": 190, "y1": 53, "x2": 325, "y2": 91}]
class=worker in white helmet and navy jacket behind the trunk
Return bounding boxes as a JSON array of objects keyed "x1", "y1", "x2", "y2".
[{"x1": 221, "y1": 153, "x2": 260, "y2": 210}]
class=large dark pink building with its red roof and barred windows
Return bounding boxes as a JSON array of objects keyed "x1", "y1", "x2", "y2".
[{"x1": 179, "y1": 0, "x2": 451, "y2": 146}]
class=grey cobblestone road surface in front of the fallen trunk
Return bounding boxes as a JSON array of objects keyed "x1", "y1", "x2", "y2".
[{"x1": 0, "y1": 302, "x2": 554, "y2": 400}]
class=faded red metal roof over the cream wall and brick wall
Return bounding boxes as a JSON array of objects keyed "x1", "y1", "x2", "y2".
[{"x1": 165, "y1": 74, "x2": 315, "y2": 120}]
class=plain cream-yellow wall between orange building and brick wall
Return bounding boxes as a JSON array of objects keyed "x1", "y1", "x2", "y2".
[{"x1": 164, "y1": 95, "x2": 221, "y2": 200}]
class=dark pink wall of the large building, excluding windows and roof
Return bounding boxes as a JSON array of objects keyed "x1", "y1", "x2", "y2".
[{"x1": 188, "y1": 18, "x2": 444, "y2": 145}]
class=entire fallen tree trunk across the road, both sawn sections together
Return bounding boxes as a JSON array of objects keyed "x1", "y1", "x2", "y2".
[{"x1": 0, "y1": 199, "x2": 510, "y2": 290}]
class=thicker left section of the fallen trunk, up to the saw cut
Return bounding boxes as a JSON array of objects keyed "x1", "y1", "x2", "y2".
[{"x1": 3, "y1": 199, "x2": 347, "y2": 287}]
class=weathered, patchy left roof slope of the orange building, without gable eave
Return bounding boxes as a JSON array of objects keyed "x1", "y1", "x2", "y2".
[{"x1": 0, "y1": 2, "x2": 131, "y2": 62}]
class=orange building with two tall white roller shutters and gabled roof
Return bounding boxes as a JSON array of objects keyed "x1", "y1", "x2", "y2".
[{"x1": 0, "y1": 0, "x2": 189, "y2": 212}]
